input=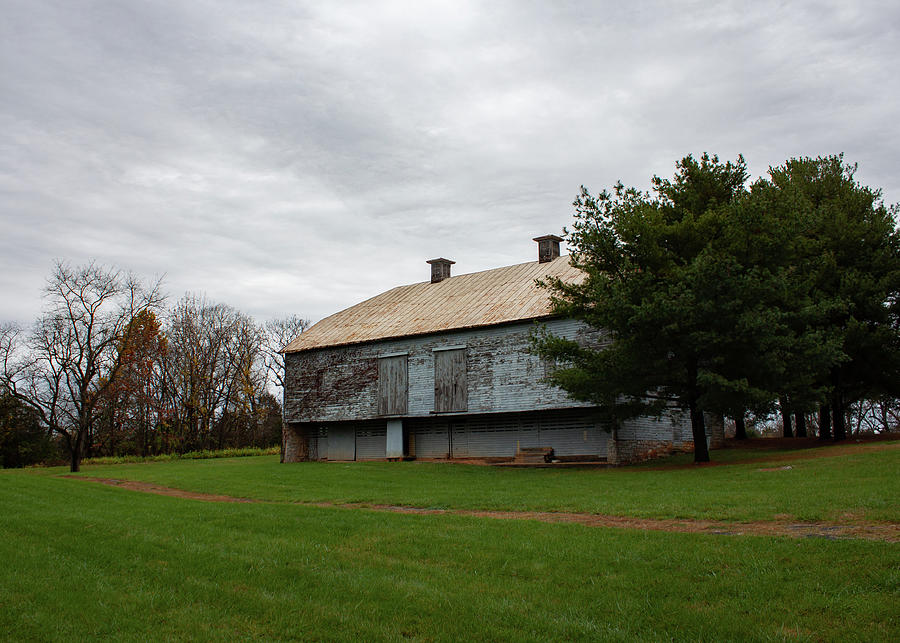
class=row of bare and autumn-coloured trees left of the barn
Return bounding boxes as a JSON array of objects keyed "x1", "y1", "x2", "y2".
[{"x1": 0, "y1": 262, "x2": 309, "y2": 471}]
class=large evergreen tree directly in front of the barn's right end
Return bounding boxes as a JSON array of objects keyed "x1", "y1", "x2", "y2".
[{"x1": 535, "y1": 154, "x2": 772, "y2": 462}]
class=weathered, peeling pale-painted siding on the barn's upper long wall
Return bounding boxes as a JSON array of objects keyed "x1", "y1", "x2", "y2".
[{"x1": 285, "y1": 319, "x2": 599, "y2": 423}]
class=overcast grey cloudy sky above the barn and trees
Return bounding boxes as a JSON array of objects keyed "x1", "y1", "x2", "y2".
[{"x1": 0, "y1": 0, "x2": 900, "y2": 323}]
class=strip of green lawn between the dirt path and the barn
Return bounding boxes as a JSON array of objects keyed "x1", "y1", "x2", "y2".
[{"x1": 59, "y1": 442, "x2": 900, "y2": 521}]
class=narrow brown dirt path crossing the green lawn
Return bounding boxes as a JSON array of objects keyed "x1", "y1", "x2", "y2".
[{"x1": 65, "y1": 476, "x2": 900, "y2": 543}]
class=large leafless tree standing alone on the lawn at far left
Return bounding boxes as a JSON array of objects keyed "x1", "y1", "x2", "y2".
[{"x1": 0, "y1": 262, "x2": 164, "y2": 471}]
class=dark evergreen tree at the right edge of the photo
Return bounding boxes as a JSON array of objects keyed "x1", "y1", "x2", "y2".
[{"x1": 752, "y1": 155, "x2": 900, "y2": 439}]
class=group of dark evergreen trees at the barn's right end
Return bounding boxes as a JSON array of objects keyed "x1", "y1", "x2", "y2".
[{"x1": 534, "y1": 154, "x2": 900, "y2": 462}]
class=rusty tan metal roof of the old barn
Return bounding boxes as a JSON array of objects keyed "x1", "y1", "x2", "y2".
[{"x1": 284, "y1": 257, "x2": 584, "y2": 353}]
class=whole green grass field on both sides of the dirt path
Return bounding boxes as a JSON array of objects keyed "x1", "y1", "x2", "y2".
[{"x1": 0, "y1": 445, "x2": 900, "y2": 641}]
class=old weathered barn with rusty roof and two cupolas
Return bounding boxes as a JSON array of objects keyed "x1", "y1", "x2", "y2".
[{"x1": 284, "y1": 235, "x2": 693, "y2": 463}]
